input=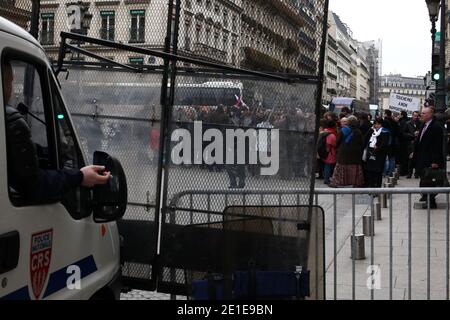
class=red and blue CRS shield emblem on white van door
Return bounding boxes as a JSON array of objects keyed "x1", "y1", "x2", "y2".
[{"x1": 30, "y1": 229, "x2": 53, "y2": 299}]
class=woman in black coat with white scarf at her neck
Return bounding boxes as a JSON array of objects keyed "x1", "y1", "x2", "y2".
[{"x1": 365, "y1": 118, "x2": 390, "y2": 188}]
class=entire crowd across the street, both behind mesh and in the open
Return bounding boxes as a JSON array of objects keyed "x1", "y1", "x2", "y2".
[{"x1": 151, "y1": 100, "x2": 450, "y2": 202}]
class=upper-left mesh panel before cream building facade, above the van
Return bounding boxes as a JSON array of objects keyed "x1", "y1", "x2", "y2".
[{"x1": 39, "y1": 0, "x2": 170, "y2": 66}]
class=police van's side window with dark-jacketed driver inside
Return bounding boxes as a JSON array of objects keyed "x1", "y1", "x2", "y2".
[{"x1": 1, "y1": 58, "x2": 56, "y2": 206}]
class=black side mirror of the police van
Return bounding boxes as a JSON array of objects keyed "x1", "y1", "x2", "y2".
[{"x1": 93, "y1": 151, "x2": 128, "y2": 223}]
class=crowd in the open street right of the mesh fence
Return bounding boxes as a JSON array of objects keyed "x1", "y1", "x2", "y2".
[{"x1": 317, "y1": 107, "x2": 445, "y2": 194}]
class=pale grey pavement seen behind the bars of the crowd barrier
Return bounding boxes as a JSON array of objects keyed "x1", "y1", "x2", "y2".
[{"x1": 317, "y1": 168, "x2": 447, "y2": 300}]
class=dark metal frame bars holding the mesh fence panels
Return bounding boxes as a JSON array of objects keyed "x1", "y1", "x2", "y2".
[{"x1": 48, "y1": 0, "x2": 329, "y2": 288}]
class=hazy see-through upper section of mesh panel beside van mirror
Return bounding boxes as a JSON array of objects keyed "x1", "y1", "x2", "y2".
[{"x1": 59, "y1": 68, "x2": 162, "y2": 205}]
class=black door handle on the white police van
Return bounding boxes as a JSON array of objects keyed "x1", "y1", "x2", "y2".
[{"x1": 0, "y1": 231, "x2": 20, "y2": 274}]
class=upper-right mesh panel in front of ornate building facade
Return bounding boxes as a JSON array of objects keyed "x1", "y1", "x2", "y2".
[{"x1": 177, "y1": 0, "x2": 325, "y2": 75}]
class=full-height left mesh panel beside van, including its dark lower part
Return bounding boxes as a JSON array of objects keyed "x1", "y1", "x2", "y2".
[{"x1": 59, "y1": 67, "x2": 162, "y2": 289}]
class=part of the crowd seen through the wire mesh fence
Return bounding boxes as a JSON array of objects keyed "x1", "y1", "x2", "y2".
[{"x1": 150, "y1": 105, "x2": 316, "y2": 189}]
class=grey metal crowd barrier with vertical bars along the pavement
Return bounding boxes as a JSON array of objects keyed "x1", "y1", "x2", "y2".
[{"x1": 169, "y1": 188, "x2": 450, "y2": 300}]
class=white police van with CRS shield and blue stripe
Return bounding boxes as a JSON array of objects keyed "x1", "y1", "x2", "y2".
[{"x1": 0, "y1": 17, "x2": 127, "y2": 300}]
